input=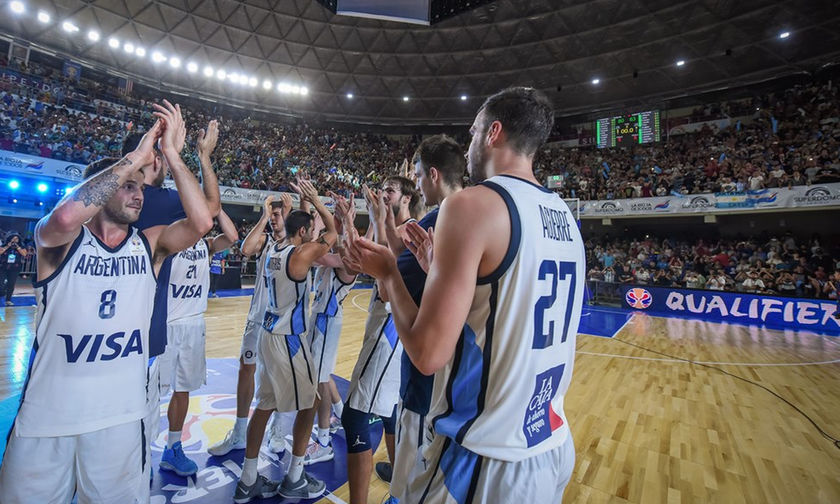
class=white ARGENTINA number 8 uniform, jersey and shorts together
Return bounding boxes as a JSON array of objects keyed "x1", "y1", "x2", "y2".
[{"x1": 0, "y1": 226, "x2": 155, "y2": 504}]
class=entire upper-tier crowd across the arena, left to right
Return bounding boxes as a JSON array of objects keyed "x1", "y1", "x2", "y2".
[{"x1": 0, "y1": 55, "x2": 840, "y2": 200}]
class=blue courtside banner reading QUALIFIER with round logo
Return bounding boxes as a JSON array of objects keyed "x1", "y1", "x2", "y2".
[{"x1": 620, "y1": 284, "x2": 840, "y2": 334}]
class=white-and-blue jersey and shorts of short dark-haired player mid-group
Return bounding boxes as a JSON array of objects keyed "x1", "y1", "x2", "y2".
[{"x1": 255, "y1": 243, "x2": 317, "y2": 412}]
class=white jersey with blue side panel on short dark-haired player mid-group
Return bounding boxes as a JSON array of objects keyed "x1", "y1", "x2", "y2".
[{"x1": 262, "y1": 243, "x2": 310, "y2": 336}]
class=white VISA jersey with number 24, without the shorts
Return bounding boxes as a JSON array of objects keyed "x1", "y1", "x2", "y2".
[{"x1": 164, "y1": 238, "x2": 210, "y2": 322}]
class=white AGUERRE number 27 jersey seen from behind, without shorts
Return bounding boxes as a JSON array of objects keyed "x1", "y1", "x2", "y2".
[{"x1": 429, "y1": 176, "x2": 586, "y2": 461}]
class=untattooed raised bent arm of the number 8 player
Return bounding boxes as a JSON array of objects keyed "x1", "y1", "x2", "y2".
[{"x1": 145, "y1": 100, "x2": 213, "y2": 264}]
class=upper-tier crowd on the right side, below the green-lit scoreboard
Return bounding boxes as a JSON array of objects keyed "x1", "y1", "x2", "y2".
[{"x1": 538, "y1": 83, "x2": 840, "y2": 200}]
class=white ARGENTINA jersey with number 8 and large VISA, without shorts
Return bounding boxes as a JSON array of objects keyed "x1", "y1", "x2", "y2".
[{"x1": 15, "y1": 226, "x2": 156, "y2": 437}]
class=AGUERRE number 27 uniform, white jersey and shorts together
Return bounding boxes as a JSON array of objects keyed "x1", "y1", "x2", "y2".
[{"x1": 400, "y1": 176, "x2": 586, "y2": 503}]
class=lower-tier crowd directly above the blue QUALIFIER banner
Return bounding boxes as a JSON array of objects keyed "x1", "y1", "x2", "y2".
[{"x1": 586, "y1": 233, "x2": 840, "y2": 300}]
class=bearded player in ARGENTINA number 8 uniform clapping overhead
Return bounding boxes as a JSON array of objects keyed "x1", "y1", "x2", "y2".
[{"x1": 0, "y1": 101, "x2": 212, "y2": 504}]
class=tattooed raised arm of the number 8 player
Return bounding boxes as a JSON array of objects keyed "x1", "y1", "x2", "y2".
[{"x1": 35, "y1": 121, "x2": 162, "y2": 252}]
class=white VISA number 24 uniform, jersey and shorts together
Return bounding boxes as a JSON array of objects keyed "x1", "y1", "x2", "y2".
[{"x1": 158, "y1": 238, "x2": 210, "y2": 392}]
